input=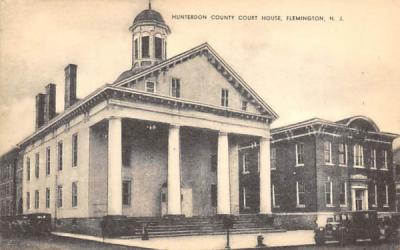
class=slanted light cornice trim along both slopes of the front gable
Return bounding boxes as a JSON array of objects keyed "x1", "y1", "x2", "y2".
[{"x1": 112, "y1": 42, "x2": 279, "y2": 122}]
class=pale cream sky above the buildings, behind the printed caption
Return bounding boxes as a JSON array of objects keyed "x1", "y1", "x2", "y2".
[{"x1": 0, "y1": 0, "x2": 400, "y2": 154}]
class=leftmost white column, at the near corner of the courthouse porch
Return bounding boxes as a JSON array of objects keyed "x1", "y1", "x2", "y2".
[{"x1": 107, "y1": 117, "x2": 122, "y2": 215}]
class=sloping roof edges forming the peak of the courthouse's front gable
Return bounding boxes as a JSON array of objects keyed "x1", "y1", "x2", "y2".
[{"x1": 112, "y1": 43, "x2": 279, "y2": 121}]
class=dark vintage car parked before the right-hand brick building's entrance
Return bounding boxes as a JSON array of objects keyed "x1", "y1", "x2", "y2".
[{"x1": 314, "y1": 211, "x2": 391, "y2": 245}]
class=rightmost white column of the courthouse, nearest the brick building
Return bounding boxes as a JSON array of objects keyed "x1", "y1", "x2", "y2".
[{"x1": 259, "y1": 137, "x2": 271, "y2": 214}]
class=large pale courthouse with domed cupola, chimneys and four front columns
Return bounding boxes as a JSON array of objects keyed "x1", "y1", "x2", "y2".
[{"x1": 19, "y1": 4, "x2": 277, "y2": 227}]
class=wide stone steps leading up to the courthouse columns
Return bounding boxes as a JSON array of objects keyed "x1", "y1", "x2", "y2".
[{"x1": 127, "y1": 215, "x2": 283, "y2": 238}]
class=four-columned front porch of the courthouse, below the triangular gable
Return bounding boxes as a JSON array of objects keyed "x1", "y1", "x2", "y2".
[{"x1": 95, "y1": 102, "x2": 271, "y2": 216}]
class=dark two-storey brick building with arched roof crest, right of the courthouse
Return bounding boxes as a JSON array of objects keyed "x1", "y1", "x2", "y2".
[{"x1": 271, "y1": 116, "x2": 398, "y2": 228}]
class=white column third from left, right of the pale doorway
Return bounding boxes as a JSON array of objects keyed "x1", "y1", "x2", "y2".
[{"x1": 217, "y1": 132, "x2": 231, "y2": 214}]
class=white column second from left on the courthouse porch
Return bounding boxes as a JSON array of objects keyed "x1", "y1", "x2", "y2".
[{"x1": 167, "y1": 124, "x2": 182, "y2": 215}]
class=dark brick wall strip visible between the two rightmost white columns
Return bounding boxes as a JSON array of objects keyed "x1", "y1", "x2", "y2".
[{"x1": 239, "y1": 147, "x2": 260, "y2": 214}]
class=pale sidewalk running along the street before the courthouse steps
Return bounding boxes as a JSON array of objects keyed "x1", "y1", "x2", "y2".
[{"x1": 53, "y1": 230, "x2": 315, "y2": 250}]
